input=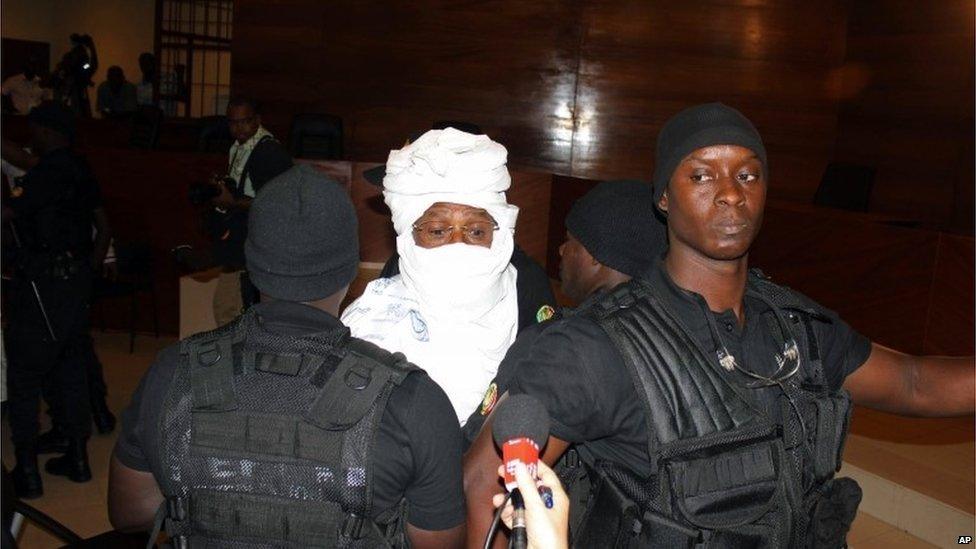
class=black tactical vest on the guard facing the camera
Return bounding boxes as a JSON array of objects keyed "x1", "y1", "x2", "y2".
[{"x1": 561, "y1": 271, "x2": 860, "y2": 549}]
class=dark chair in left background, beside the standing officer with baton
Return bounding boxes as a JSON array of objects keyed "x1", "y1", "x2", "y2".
[{"x1": 95, "y1": 242, "x2": 159, "y2": 354}]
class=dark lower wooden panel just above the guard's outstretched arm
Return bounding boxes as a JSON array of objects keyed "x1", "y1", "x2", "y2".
[{"x1": 750, "y1": 202, "x2": 936, "y2": 354}]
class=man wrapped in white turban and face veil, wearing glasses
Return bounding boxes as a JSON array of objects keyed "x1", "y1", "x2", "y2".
[{"x1": 342, "y1": 128, "x2": 548, "y2": 424}]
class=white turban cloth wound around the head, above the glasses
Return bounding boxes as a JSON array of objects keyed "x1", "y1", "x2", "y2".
[{"x1": 383, "y1": 128, "x2": 518, "y2": 235}]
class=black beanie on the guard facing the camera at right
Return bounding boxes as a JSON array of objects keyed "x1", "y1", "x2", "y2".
[{"x1": 654, "y1": 103, "x2": 769, "y2": 207}]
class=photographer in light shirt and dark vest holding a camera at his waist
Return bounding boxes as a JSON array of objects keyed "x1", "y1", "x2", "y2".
[{"x1": 207, "y1": 96, "x2": 292, "y2": 326}]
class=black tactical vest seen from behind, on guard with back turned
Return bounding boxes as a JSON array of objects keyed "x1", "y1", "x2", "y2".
[{"x1": 151, "y1": 309, "x2": 417, "y2": 548}]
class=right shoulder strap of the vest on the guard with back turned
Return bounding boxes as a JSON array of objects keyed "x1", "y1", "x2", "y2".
[{"x1": 305, "y1": 338, "x2": 420, "y2": 431}]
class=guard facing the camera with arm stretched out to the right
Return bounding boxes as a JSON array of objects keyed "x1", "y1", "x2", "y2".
[{"x1": 465, "y1": 103, "x2": 976, "y2": 548}]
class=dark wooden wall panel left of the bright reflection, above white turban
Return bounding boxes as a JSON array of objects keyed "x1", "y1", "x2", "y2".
[{"x1": 233, "y1": 0, "x2": 577, "y2": 169}]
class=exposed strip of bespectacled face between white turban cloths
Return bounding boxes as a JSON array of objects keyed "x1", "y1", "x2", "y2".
[{"x1": 413, "y1": 202, "x2": 498, "y2": 248}]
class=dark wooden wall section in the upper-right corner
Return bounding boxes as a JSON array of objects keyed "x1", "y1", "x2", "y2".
[{"x1": 836, "y1": 0, "x2": 974, "y2": 234}]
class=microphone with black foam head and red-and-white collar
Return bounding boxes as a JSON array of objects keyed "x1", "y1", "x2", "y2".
[{"x1": 491, "y1": 395, "x2": 549, "y2": 491}]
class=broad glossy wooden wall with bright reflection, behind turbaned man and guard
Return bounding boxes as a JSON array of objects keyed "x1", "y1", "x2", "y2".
[{"x1": 233, "y1": 0, "x2": 846, "y2": 198}]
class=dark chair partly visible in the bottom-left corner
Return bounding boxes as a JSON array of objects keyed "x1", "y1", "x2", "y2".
[{"x1": 0, "y1": 466, "x2": 149, "y2": 549}]
